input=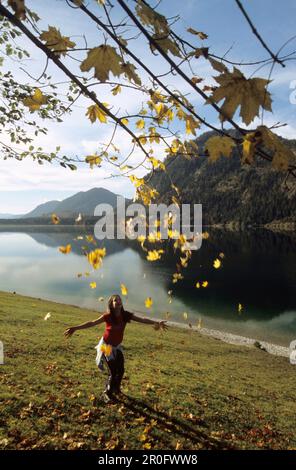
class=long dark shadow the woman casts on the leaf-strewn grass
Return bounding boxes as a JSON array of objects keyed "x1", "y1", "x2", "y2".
[{"x1": 116, "y1": 394, "x2": 236, "y2": 450}]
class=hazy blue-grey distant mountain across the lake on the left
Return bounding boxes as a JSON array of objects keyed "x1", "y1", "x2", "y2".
[{"x1": 22, "y1": 188, "x2": 121, "y2": 218}]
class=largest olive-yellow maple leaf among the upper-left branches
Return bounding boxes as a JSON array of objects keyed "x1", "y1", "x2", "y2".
[{"x1": 80, "y1": 45, "x2": 123, "y2": 82}]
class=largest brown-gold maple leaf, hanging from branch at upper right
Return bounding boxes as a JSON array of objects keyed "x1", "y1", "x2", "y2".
[{"x1": 207, "y1": 67, "x2": 272, "y2": 125}]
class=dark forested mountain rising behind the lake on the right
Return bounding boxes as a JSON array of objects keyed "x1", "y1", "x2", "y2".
[{"x1": 148, "y1": 132, "x2": 296, "y2": 224}]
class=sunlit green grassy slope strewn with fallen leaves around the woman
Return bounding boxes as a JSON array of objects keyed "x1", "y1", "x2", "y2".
[{"x1": 0, "y1": 292, "x2": 296, "y2": 450}]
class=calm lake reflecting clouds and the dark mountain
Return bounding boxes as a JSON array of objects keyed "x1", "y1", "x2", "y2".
[{"x1": 0, "y1": 226, "x2": 296, "y2": 346}]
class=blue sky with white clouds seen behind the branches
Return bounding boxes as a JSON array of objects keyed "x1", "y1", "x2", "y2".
[{"x1": 0, "y1": 0, "x2": 296, "y2": 214}]
